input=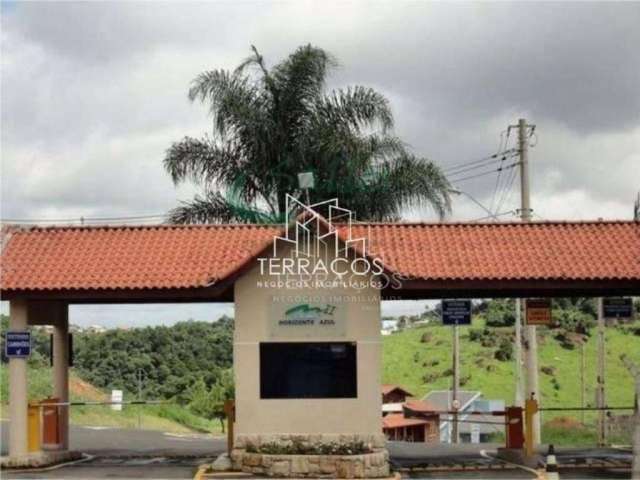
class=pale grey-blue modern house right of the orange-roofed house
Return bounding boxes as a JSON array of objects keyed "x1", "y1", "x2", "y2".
[{"x1": 423, "y1": 390, "x2": 505, "y2": 443}]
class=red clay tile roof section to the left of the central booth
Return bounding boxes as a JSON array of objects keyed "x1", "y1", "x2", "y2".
[{"x1": 1, "y1": 225, "x2": 282, "y2": 291}]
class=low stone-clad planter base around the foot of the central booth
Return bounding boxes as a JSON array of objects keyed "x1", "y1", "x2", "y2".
[{"x1": 231, "y1": 434, "x2": 389, "y2": 478}]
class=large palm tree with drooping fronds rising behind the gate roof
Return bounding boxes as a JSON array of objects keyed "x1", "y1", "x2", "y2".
[{"x1": 164, "y1": 45, "x2": 450, "y2": 223}]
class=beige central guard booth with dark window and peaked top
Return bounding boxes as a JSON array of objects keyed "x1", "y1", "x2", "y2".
[{"x1": 234, "y1": 217, "x2": 384, "y2": 449}]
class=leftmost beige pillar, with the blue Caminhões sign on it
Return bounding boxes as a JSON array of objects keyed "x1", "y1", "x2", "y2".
[{"x1": 9, "y1": 300, "x2": 28, "y2": 458}]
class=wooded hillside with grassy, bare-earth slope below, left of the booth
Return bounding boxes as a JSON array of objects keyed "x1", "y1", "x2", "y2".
[{"x1": 0, "y1": 315, "x2": 233, "y2": 432}]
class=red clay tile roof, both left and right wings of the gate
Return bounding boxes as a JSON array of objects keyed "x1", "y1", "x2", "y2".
[{"x1": 0, "y1": 221, "x2": 640, "y2": 292}]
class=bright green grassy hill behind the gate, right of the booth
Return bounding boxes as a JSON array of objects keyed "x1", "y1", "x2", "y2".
[{"x1": 383, "y1": 321, "x2": 640, "y2": 443}]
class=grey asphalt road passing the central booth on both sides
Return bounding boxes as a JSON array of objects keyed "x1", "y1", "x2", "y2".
[{"x1": 0, "y1": 421, "x2": 631, "y2": 479}]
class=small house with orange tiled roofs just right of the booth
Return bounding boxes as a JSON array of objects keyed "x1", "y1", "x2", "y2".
[{"x1": 382, "y1": 385, "x2": 440, "y2": 443}]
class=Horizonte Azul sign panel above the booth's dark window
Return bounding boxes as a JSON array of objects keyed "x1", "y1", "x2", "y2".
[{"x1": 269, "y1": 297, "x2": 347, "y2": 339}]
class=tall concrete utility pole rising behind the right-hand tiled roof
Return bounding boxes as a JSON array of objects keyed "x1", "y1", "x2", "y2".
[{"x1": 517, "y1": 118, "x2": 540, "y2": 445}]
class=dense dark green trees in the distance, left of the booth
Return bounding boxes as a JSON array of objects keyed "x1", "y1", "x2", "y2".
[{"x1": 1, "y1": 315, "x2": 234, "y2": 427}]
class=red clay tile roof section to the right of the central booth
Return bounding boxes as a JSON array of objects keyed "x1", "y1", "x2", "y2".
[{"x1": 352, "y1": 221, "x2": 640, "y2": 280}]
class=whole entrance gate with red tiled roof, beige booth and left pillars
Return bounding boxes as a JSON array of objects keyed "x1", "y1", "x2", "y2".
[{"x1": 0, "y1": 220, "x2": 640, "y2": 470}]
